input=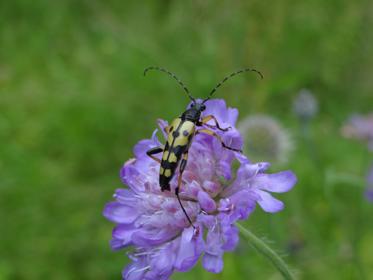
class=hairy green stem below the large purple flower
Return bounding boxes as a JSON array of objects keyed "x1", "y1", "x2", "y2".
[{"x1": 236, "y1": 223, "x2": 295, "y2": 280}]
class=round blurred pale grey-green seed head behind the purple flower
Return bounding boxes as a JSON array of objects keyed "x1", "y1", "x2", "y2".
[{"x1": 237, "y1": 115, "x2": 294, "y2": 163}]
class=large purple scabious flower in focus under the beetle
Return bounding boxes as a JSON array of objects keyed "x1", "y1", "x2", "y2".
[{"x1": 104, "y1": 100, "x2": 296, "y2": 279}]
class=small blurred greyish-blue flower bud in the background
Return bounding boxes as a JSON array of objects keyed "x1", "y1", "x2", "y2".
[{"x1": 293, "y1": 89, "x2": 319, "y2": 120}]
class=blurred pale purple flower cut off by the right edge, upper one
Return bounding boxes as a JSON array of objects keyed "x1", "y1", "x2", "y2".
[{"x1": 342, "y1": 113, "x2": 373, "y2": 151}]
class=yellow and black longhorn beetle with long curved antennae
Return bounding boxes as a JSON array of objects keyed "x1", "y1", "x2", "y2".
[{"x1": 144, "y1": 66, "x2": 263, "y2": 228}]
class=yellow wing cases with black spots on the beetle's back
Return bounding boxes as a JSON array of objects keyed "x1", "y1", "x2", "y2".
[{"x1": 159, "y1": 118, "x2": 195, "y2": 191}]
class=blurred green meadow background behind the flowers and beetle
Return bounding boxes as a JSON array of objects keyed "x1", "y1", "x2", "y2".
[{"x1": 0, "y1": 0, "x2": 373, "y2": 279}]
